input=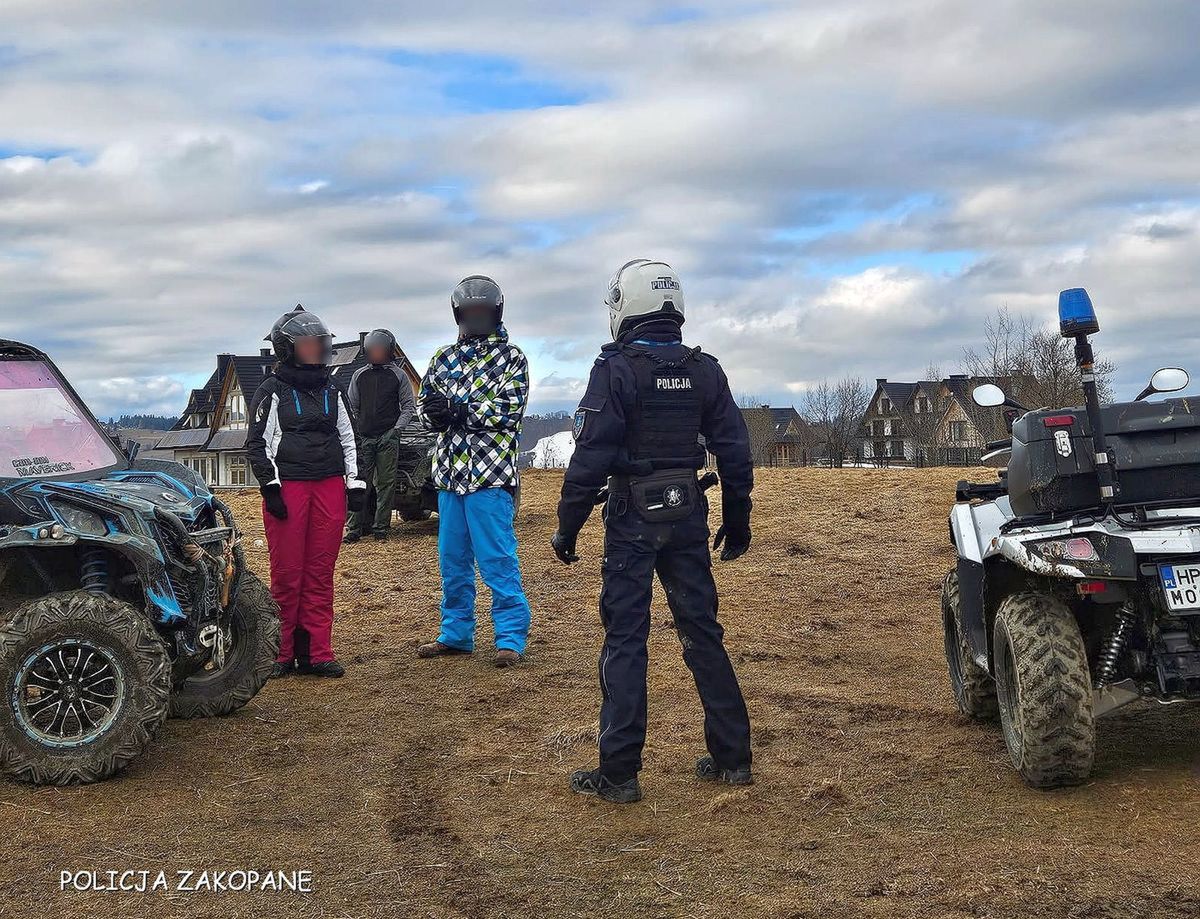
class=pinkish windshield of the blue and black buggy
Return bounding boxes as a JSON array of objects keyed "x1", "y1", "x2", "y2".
[{"x1": 0, "y1": 361, "x2": 124, "y2": 479}]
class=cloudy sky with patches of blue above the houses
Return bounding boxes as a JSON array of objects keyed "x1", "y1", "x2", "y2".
[{"x1": 0, "y1": 0, "x2": 1200, "y2": 415}]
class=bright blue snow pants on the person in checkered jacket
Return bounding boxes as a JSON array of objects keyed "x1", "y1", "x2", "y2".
[{"x1": 438, "y1": 488, "x2": 529, "y2": 654}]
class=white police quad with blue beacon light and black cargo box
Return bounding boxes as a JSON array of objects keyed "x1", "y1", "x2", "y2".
[{"x1": 942, "y1": 289, "x2": 1200, "y2": 788}]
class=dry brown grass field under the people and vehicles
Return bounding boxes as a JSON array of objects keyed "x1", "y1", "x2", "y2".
[{"x1": 0, "y1": 469, "x2": 1200, "y2": 919}]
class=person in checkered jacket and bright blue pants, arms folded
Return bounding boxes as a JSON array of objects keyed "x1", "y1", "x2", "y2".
[{"x1": 416, "y1": 275, "x2": 530, "y2": 667}]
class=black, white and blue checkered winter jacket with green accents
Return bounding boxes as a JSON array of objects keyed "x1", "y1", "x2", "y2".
[{"x1": 419, "y1": 325, "x2": 529, "y2": 494}]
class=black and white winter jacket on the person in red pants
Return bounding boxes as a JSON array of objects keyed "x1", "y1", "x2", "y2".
[{"x1": 246, "y1": 365, "x2": 366, "y2": 488}]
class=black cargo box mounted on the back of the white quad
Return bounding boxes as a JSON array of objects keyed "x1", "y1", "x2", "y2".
[{"x1": 1008, "y1": 398, "x2": 1200, "y2": 517}]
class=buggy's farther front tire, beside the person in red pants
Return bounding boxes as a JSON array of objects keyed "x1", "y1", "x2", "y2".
[{"x1": 170, "y1": 571, "x2": 280, "y2": 717}]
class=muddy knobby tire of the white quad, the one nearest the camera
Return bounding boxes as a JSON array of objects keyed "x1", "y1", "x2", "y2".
[{"x1": 994, "y1": 593, "x2": 1096, "y2": 788}]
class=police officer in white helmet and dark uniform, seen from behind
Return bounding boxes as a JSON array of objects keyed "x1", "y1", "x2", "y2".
[{"x1": 551, "y1": 259, "x2": 754, "y2": 804}]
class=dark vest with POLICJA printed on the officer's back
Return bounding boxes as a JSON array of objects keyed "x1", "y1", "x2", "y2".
[{"x1": 622, "y1": 347, "x2": 704, "y2": 469}]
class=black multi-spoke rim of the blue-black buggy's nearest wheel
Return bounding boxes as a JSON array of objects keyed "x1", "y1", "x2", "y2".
[{"x1": 12, "y1": 638, "x2": 125, "y2": 747}]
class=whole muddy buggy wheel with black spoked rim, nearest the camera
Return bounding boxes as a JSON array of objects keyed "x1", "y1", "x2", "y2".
[{"x1": 0, "y1": 590, "x2": 170, "y2": 785}]
